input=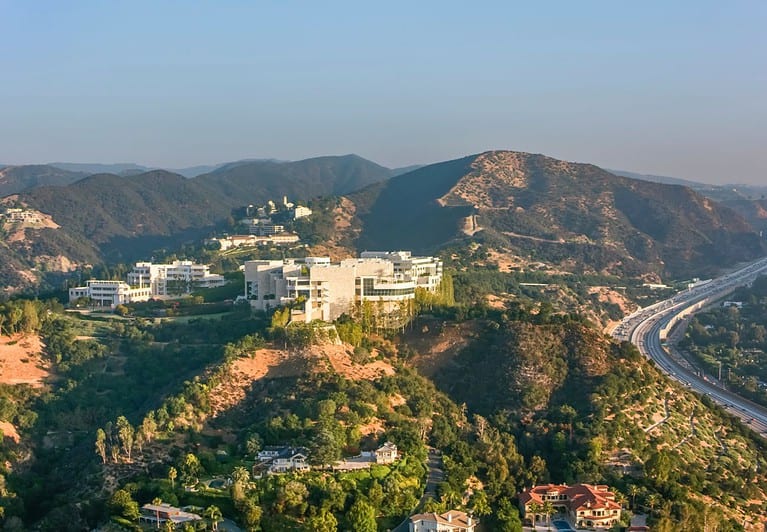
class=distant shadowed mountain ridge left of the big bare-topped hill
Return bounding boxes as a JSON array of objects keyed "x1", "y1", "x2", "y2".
[{"x1": 0, "y1": 155, "x2": 390, "y2": 288}]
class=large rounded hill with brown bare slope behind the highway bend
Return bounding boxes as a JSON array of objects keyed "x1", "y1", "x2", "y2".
[{"x1": 349, "y1": 151, "x2": 767, "y2": 277}]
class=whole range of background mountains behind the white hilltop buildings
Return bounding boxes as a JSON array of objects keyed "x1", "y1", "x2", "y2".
[{"x1": 0, "y1": 151, "x2": 767, "y2": 287}]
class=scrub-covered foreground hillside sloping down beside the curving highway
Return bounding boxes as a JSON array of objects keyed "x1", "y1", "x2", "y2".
[{"x1": 405, "y1": 313, "x2": 767, "y2": 530}]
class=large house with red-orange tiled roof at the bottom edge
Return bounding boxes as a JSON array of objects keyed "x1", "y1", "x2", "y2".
[{"x1": 519, "y1": 484, "x2": 622, "y2": 528}]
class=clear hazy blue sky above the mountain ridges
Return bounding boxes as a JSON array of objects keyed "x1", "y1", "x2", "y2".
[{"x1": 0, "y1": 0, "x2": 767, "y2": 184}]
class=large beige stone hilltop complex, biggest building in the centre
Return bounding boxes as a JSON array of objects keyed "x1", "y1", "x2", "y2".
[{"x1": 245, "y1": 251, "x2": 442, "y2": 323}]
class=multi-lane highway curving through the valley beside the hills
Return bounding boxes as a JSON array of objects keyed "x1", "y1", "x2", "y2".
[{"x1": 612, "y1": 258, "x2": 767, "y2": 437}]
